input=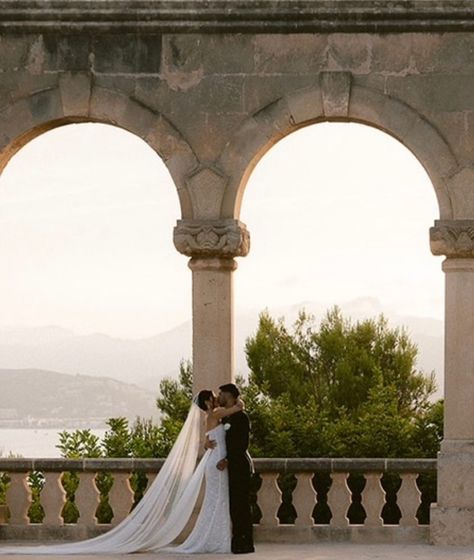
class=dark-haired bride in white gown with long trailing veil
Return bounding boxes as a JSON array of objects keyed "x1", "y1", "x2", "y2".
[{"x1": 0, "y1": 390, "x2": 243, "y2": 557}]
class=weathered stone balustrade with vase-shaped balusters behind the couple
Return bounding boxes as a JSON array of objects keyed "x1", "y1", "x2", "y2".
[{"x1": 0, "y1": 458, "x2": 436, "y2": 542}]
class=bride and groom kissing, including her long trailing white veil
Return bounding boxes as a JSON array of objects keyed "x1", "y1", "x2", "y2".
[{"x1": 0, "y1": 383, "x2": 254, "y2": 556}]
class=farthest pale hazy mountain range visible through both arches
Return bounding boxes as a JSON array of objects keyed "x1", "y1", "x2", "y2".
[{"x1": 0, "y1": 298, "x2": 444, "y2": 396}]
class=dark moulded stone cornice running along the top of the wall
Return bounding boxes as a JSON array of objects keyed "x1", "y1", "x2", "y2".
[{"x1": 0, "y1": 0, "x2": 474, "y2": 33}]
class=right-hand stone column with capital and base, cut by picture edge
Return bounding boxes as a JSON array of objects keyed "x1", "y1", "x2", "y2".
[{"x1": 430, "y1": 220, "x2": 474, "y2": 545}]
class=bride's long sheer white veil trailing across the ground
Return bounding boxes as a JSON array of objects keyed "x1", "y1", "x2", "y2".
[{"x1": 0, "y1": 399, "x2": 209, "y2": 556}]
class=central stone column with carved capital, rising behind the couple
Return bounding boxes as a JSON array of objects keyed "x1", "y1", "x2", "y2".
[{"x1": 174, "y1": 219, "x2": 250, "y2": 393}]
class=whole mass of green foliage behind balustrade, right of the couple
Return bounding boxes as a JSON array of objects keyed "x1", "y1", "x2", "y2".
[{"x1": 240, "y1": 307, "x2": 443, "y2": 457}]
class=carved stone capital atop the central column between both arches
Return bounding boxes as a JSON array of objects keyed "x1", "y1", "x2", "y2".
[{"x1": 173, "y1": 218, "x2": 250, "y2": 259}]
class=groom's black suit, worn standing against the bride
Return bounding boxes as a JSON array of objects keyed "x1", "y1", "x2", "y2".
[{"x1": 223, "y1": 410, "x2": 254, "y2": 553}]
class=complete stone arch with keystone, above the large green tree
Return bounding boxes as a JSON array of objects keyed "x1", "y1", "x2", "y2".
[{"x1": 218, "y1": 75, "x2": 459, "y2": 219}]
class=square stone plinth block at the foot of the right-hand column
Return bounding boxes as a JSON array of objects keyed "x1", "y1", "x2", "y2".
[{"x1": 430, "y1": 503, "x2": 474, "y2": 546}]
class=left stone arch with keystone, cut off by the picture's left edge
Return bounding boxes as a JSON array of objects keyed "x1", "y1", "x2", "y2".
[{"x1": 0, "y1": 83, "x2": 199, "y2": 218}]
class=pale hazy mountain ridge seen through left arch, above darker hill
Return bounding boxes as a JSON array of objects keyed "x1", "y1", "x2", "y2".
[{"x1": 0, "y1": 323, "x2": 191, "y2": 394}]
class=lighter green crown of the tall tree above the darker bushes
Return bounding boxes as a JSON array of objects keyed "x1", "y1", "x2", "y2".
[{"x1": 245, "y1": 306, "x2": 435, "y2": 414}]
